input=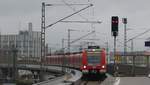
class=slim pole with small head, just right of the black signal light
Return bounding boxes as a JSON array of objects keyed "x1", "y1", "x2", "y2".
[{"x1": 122, "y1": 18, "x2": 127, "y2": 63}]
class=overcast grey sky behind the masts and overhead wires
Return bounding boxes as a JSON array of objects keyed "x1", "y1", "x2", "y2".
[{"x1": 0, "y1": 0, "x2": 150, "y2": 51}]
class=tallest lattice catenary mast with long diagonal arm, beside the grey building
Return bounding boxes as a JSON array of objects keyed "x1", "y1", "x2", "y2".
[{"x1": 40, "y1": 2, "x2": 93, "y2": 81}]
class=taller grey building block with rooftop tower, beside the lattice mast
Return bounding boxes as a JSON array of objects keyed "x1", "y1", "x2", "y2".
[{"x1": 17, "y1": 23, "x2": 41, "y2": 57}]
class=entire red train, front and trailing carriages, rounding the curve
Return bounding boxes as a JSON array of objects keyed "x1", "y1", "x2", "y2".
[{"x1": 46, "y1": 46, "x2": 107, "y2": 74}]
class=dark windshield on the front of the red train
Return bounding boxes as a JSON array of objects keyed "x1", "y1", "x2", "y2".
[{"x1": 87, "y1": 52, "x2": 101, "y2": 65}]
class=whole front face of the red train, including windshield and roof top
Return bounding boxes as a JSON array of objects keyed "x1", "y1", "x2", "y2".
[{"x1": 80, "y1": 46, "x2": 106, "y2": 74}]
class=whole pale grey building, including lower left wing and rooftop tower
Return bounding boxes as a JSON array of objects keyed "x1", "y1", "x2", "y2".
[{"x1": 0, "y1": 23, "x2": 41, "y2": 58}]
